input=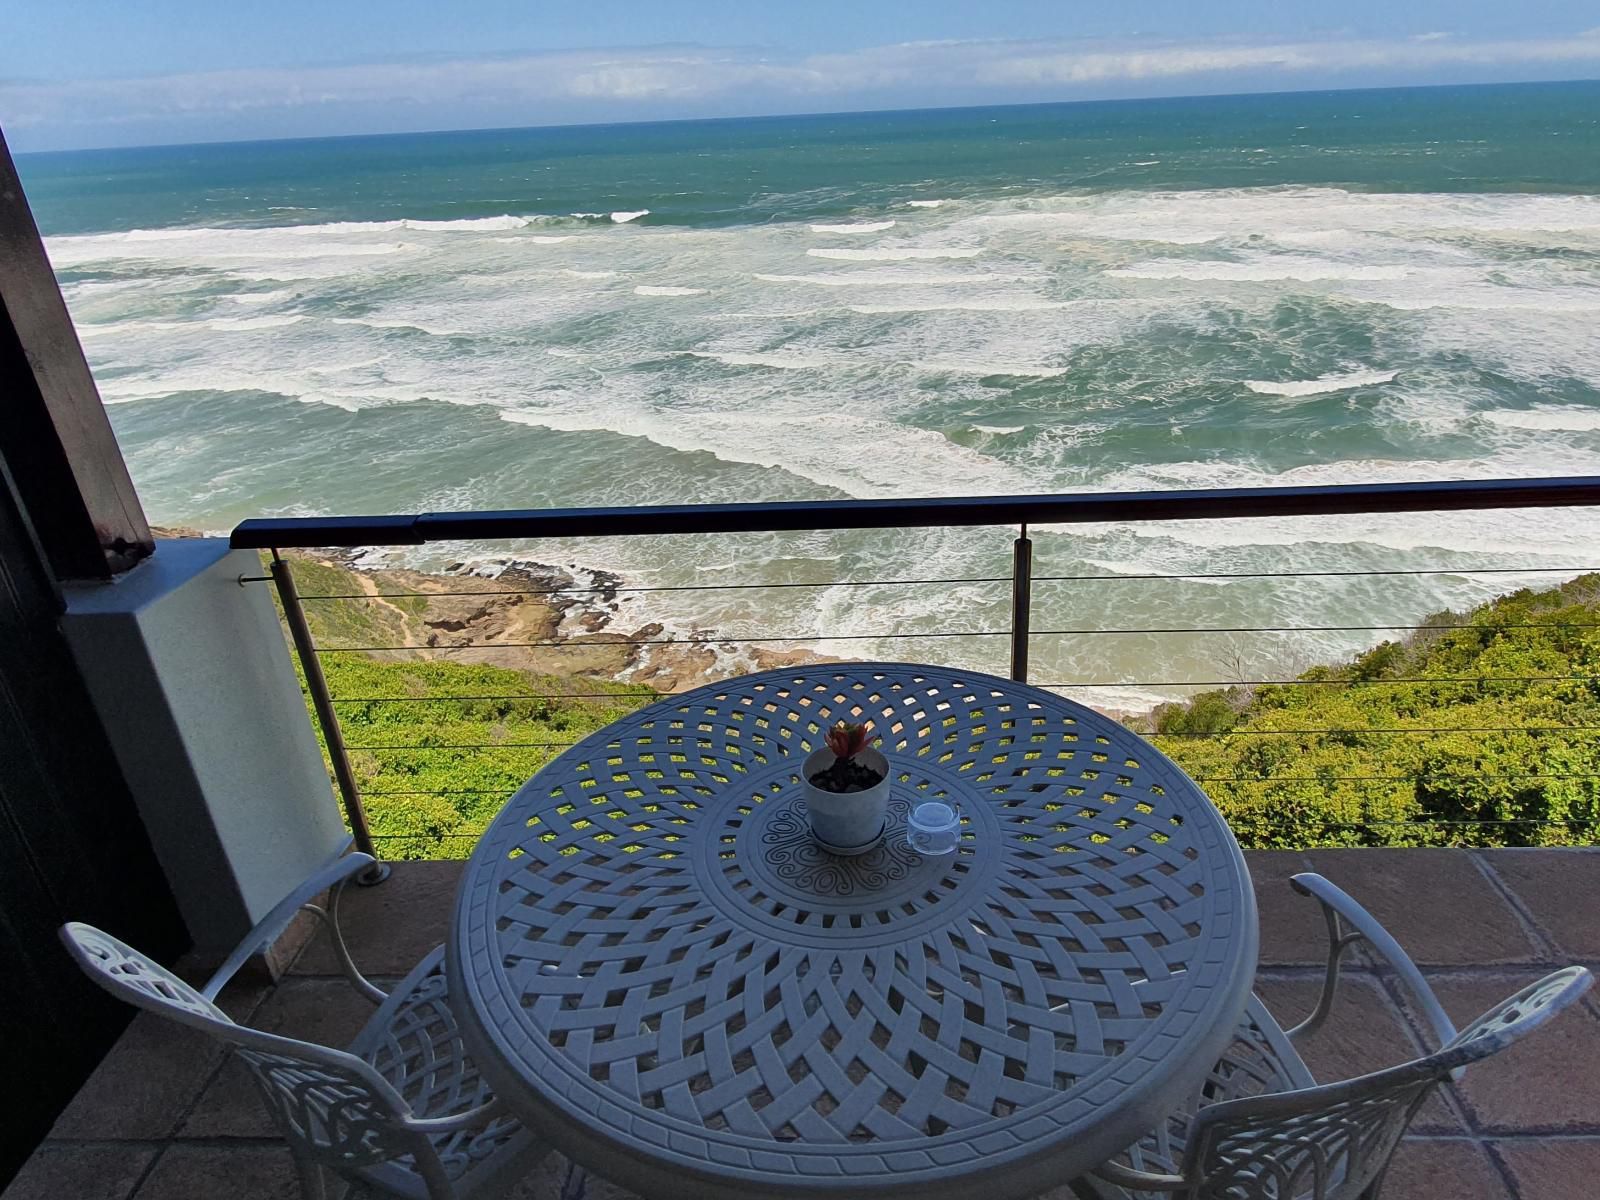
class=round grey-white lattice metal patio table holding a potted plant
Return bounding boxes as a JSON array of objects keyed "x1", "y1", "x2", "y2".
[{"x1": 448, "y1": 662, "x2": 1256, "y2": 1200}]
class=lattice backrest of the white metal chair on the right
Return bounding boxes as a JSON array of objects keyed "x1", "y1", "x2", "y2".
[{"x1": 1179, "y1": 966, "x2": 1594, "y2": 1200}]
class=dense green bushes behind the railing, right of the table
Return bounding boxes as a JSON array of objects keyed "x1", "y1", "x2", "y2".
[{"x1": 1144, "y1": 574, "x2": 1600, "y2": 848}]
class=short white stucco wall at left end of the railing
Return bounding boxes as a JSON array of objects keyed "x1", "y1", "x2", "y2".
[{"x1": 62, "y1": 538, "x2": 347, "y2": 950}]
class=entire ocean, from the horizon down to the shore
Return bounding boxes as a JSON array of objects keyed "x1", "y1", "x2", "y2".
[{"x1": 18, "y1": 83, "x2": 1600, "y2": 707}]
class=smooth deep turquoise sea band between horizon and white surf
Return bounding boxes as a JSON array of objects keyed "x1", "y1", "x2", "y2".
[{"x1": 21, "y1": 83, "x2": 1600, "y2": 234}]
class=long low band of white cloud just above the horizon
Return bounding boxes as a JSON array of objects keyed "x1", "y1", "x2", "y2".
[{"x1": 9, "y1": 30, "x2": 1600, "y2": 145}]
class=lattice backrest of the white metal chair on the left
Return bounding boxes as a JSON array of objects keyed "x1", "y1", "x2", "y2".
[{"x1": 61, "y1": 922, "x2": 432, "y2": 1166}]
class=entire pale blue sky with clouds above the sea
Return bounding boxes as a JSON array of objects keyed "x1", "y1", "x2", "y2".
[{"x1": 9, "y1": 0, "x2": 1600, "y2": 152}]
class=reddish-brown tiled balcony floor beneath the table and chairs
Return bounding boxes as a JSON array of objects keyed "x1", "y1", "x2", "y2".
[{"x1": 3, "y1": 850, "x2": 1600, "y2": 1200}]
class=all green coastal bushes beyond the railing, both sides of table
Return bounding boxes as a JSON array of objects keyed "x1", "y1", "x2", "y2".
[{"x1": 281, "y1": 558, "x2": 1600, "y2": 858}]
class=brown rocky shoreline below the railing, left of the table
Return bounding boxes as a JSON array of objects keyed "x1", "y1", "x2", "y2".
[{"x1": 155, "y1": 526, "x2": 840, "y2": 693}]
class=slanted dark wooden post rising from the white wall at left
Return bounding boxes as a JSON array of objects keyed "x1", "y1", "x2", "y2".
[{"x1": 0, "y1": 134, "x2": 155, "y2": 579}]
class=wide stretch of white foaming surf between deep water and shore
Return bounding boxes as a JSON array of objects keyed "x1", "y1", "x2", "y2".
[{"x1": 48, "y1": 181, "x2": 1600, "y2": 710}]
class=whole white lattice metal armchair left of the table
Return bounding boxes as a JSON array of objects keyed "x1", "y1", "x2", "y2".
[{"x1": 61, "y1": 854, "x2": 547, "y2": 1200}]
